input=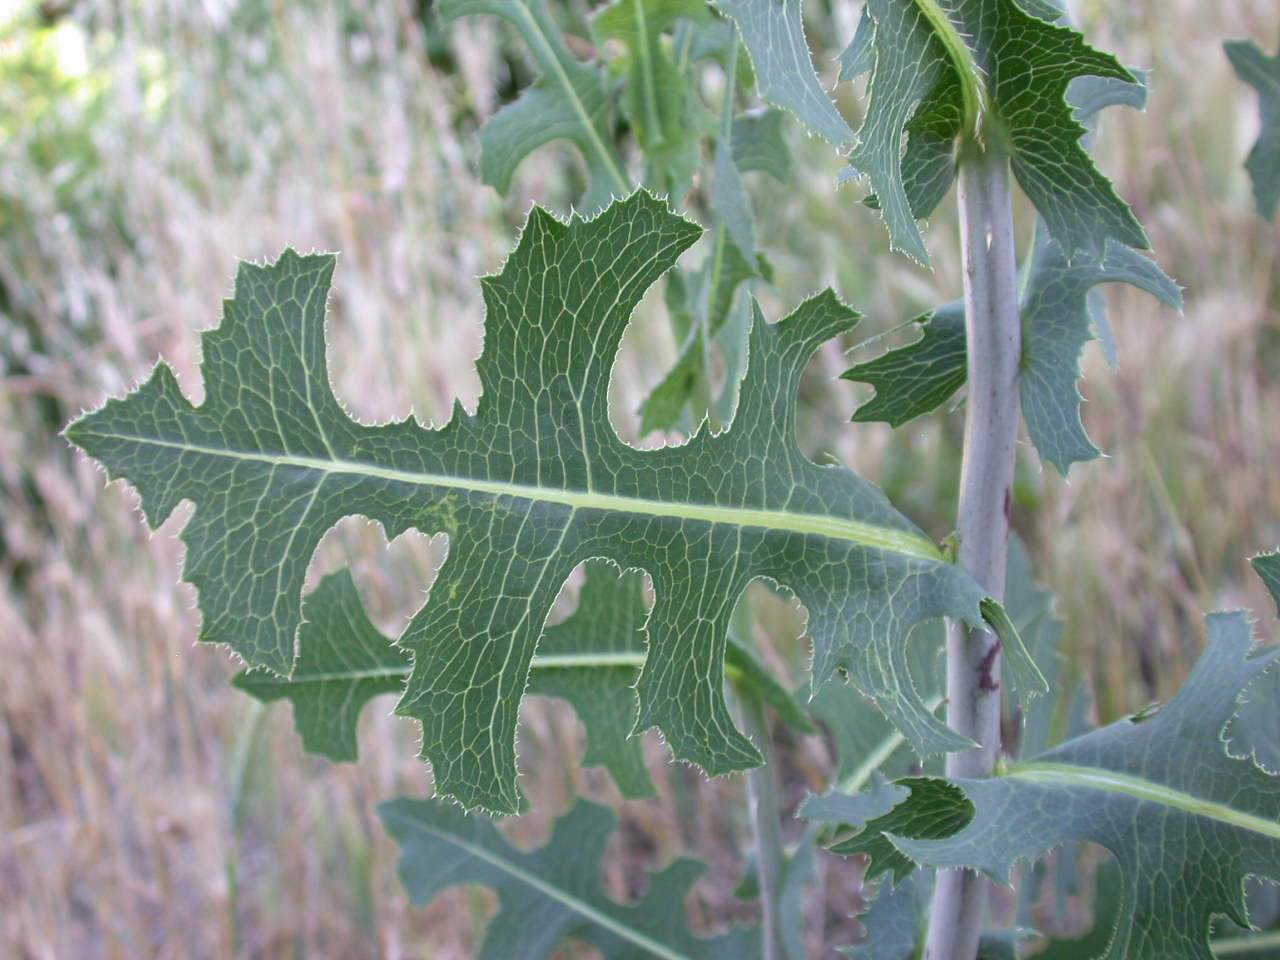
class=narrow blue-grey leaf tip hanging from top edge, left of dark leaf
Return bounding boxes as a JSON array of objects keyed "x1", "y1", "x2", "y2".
[{"x1": 714, "y1": 0, "x2": 854, "y2": 147}]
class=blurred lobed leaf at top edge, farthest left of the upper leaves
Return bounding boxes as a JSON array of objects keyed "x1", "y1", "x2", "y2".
[{"x1": 439, "y1": 0, "x2": 631, "y2": 212}]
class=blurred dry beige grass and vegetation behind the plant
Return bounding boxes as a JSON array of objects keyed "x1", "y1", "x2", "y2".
[{"x1": 0, "y1": 0, "x2": 1280, "y2": 960}]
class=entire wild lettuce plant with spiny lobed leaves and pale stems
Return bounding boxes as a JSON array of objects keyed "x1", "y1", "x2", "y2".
[{"x1": 67, "y1": 0, "x2": 1280, "y2": 960}]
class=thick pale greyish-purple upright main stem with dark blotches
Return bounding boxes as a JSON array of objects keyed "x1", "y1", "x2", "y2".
[{"x1": 924, "y1": 138, "x2": 1021, "y2": 960}]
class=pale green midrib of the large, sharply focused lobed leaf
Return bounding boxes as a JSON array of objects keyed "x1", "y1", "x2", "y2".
[{"x1": 93, "y1": 433, "x2": 942, "y2": 562}]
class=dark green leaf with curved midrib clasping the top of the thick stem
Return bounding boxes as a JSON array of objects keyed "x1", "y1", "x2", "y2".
[{"x1": 845, "y1": 0, "x2": 1147, "y2": 262}]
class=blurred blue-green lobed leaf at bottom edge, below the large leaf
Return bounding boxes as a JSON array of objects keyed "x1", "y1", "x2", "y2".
[{"x1": 379, "y1": 799, "x2": 759, "y2": 960}]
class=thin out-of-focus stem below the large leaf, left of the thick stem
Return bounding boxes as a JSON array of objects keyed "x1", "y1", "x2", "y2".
[{"x1": 737, "y1": 687, "x2": 786, "y2": 960}]
